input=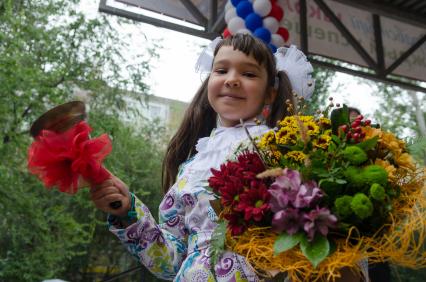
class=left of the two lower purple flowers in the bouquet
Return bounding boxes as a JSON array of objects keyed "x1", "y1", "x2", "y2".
[{"x1": 272, "y1": 208, "x2": 304, "y2": 235}]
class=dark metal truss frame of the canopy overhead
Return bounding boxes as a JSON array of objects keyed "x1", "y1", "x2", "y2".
[{"x1": 99, "y1": 0, "x2": 426, "y2": 93}]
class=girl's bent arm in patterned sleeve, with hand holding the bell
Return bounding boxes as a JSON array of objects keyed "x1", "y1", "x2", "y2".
[{"x1": 91, "y1": 177, "x2": 187, "y2": 280}]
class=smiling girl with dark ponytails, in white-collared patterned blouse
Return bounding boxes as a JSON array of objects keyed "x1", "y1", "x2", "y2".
[{"x1": 91, "y1": 34, "x2": 326, "y2": 281}]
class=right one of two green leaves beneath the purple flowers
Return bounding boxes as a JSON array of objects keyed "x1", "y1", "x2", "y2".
[{"x1": 300, "y1": 236, "x2": 330, "y2": 268}]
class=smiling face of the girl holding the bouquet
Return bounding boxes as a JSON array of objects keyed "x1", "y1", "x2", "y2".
[{"x1": 207, "y1": 46, "x2": 271, "y2": 127}]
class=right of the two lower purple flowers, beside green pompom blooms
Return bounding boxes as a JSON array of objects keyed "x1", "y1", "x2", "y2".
[{"x1": 303, "y1": 206, "x2": 337, "y2": 241}]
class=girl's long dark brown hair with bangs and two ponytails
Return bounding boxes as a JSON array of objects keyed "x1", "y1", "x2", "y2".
[{"x1": 162, "y1": 34, "x2": 292, "y2": 192}]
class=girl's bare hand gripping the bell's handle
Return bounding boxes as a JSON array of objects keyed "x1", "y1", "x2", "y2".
[{"x1": 90, "y1": 175, "x2": 131, "y2": 216}]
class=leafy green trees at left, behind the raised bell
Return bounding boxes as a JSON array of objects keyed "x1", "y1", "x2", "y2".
[{"x1": 0, "y1": 0, "x2": 164, "y2": 281}]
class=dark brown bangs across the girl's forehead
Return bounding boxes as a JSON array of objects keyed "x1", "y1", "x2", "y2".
[{"x1": 214, "y1": 33, "x2": 276, "y2": 86}]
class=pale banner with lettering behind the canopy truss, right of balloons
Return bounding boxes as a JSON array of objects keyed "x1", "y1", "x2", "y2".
[{"x1": 278, "y1": 0, "x2": 426, "y2": 81}]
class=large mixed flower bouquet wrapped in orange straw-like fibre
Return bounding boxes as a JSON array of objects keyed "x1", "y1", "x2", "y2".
[{"x1": 209, "y1": 101, "x2": 426, "y2": 281}]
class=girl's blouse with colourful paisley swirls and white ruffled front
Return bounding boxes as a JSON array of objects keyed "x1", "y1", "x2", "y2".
[{"x1": 109, "y1": 123, "x2": 269, "y2": 282}]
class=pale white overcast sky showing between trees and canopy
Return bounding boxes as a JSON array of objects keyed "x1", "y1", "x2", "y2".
[{"x1": 81, "y1": 0, "x2": 377, "y2": 117}]
